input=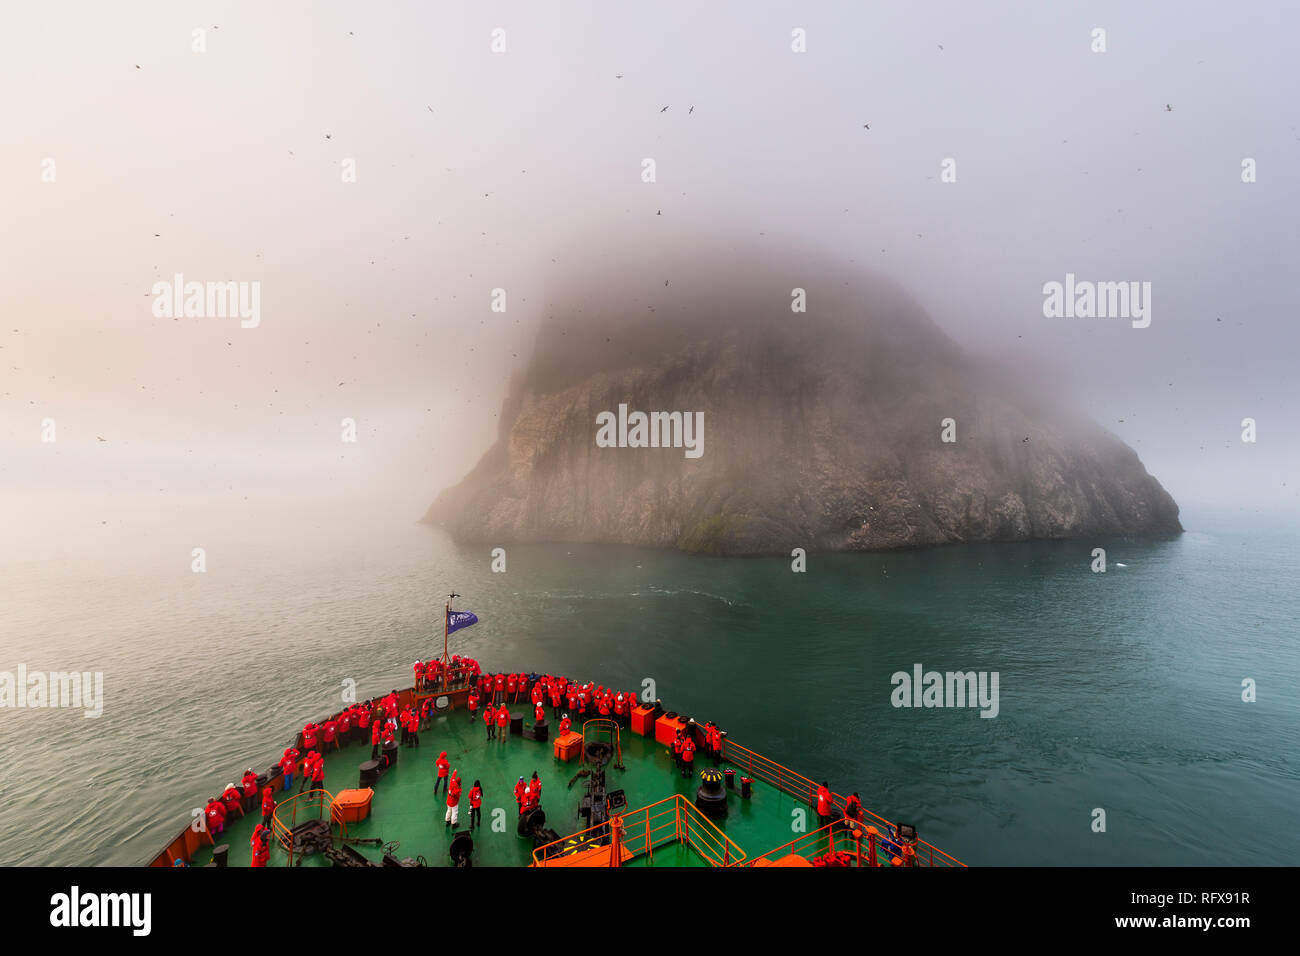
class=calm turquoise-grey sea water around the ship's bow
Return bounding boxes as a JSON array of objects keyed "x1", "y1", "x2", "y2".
[{"x1": 0, "y1": 515, "x2": 1300, "y2": 865}]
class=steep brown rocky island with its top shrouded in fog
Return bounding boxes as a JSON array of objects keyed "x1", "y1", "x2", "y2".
[{"x1": 425, "y1": 254, "x2": 1182, "y2": 554}]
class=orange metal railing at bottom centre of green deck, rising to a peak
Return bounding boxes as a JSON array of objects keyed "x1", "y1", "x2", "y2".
[{"x1": 533, "y1": 793, "x2": 745, "y2": 866}]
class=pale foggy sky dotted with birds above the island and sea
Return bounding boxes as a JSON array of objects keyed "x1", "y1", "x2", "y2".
[{"x1": 0, "y1": 0, "x2": 1300, "y2": 546}]
